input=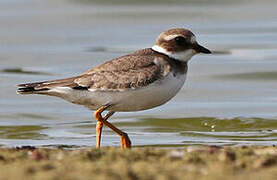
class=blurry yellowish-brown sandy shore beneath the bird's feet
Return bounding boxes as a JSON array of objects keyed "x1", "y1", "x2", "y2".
[{"x1": 0, "y1": 146, "x2": 277, "y2": 180}]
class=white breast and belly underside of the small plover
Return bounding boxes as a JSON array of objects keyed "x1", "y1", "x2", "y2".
[{"x1": 51, "y1": 74, "x2": 186, "y2": 112}]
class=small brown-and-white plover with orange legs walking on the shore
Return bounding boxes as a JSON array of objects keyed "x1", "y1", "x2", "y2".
[{"x1": 17, "y1": 28, "x2": 211, "y2": 149}]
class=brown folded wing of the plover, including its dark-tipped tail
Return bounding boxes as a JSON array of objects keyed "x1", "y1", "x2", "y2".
[{"x1": 18, "y1": 49, "x2": 170, "y2": 92}]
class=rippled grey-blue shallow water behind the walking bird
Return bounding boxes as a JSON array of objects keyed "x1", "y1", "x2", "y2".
[{"x1": 0, "y1": 0, "x2": 277, "y2": 147}]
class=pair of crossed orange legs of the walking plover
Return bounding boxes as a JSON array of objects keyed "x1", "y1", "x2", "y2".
[{"x1": 94, "y1": 106, "x2": 131, "y2": 149}]
